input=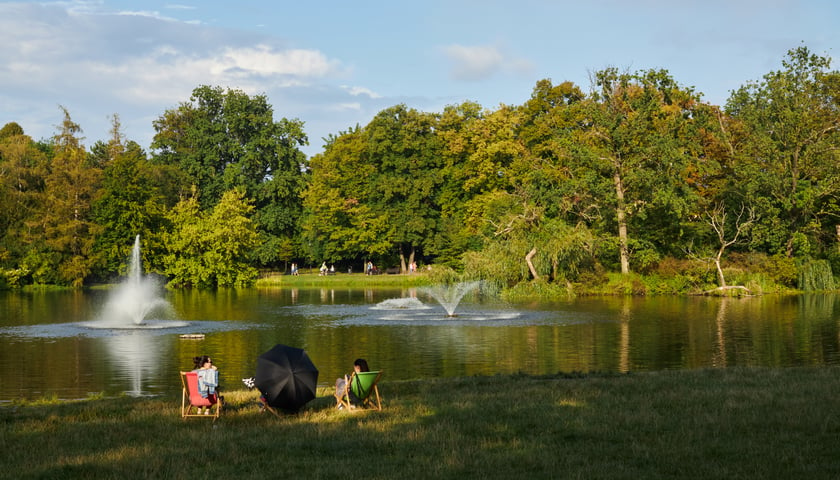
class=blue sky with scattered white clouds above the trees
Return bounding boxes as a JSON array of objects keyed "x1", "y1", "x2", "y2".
[{"x1": 0, "y1": 0, "x2": 840, "y2": 156}]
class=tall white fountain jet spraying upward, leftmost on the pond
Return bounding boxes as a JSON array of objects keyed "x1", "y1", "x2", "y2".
[{"x1": 85, "y1": 235, "x2": 188, "y2": 328}]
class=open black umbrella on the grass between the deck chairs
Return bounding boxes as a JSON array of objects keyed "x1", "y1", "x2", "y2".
[{"x1": 254, "y1": 344, "x2": 318, "y2": 411}]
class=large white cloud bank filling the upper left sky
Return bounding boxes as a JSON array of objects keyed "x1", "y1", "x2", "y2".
[{"x1": 0, "y1": 1, "x2": 426, "y2": 154}]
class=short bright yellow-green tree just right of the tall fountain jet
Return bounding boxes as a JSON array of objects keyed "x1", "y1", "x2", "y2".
[{"x1": 163, "y1": 190, "x2": 258, "y2": 288}]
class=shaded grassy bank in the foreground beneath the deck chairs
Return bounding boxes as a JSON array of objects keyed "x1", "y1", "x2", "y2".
[{"x1": 0, "y1": 368, "x2": 840, "y2": 480}]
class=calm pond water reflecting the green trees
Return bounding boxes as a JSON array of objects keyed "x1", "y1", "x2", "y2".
[{"x1": 0, "y1": 288, "x2": 840, "y2": 403}]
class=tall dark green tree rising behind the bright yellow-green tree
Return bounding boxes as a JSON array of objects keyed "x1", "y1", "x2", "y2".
[{"x1": 152, "y1": 86, "x2": 308, "y2": 264}]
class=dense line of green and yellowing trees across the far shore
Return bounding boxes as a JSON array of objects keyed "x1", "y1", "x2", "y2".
[{"x1": 0, "y1": 46, "x2": 840, "y2": 289}]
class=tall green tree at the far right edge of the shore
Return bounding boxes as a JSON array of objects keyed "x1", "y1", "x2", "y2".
[{"x1": 726, "y1": 46, "x2": 840, "y2": 256}]
